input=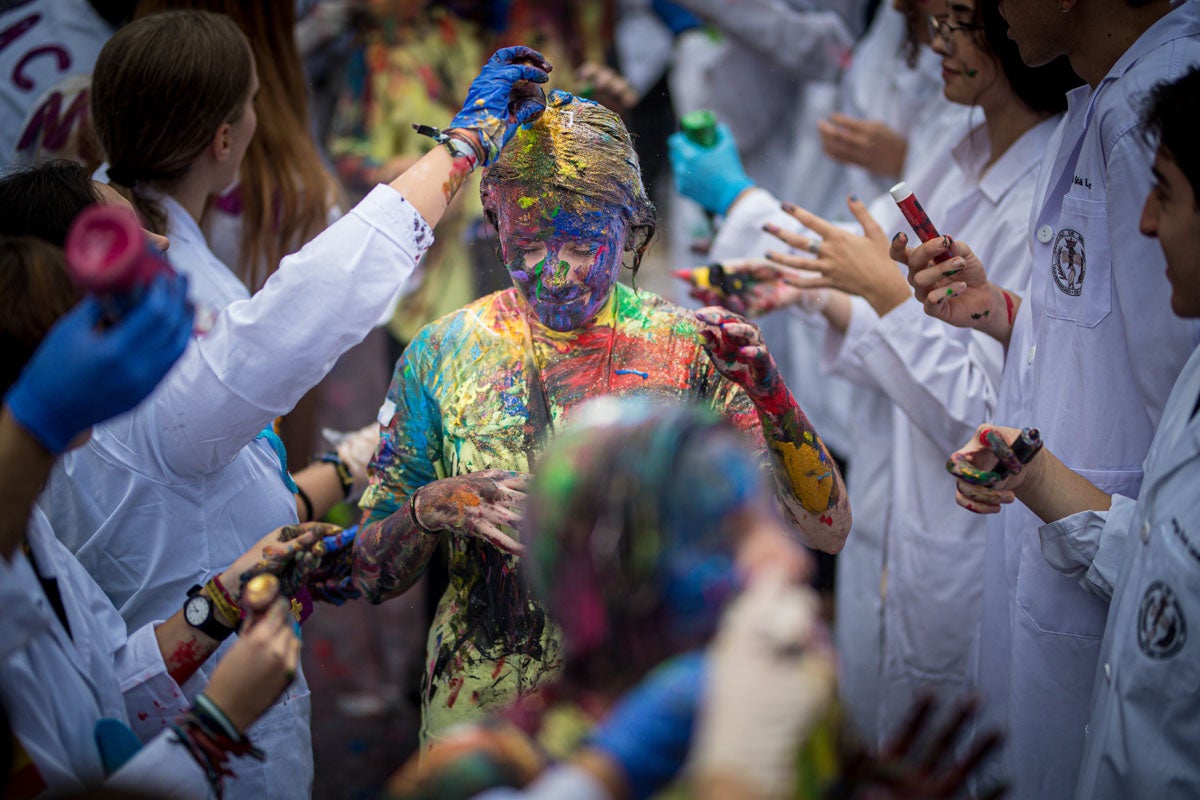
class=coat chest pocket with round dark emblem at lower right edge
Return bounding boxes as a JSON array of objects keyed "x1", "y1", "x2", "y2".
[{"x1": 1115, "y1": 518, "x2": 1200, "y2": 706}]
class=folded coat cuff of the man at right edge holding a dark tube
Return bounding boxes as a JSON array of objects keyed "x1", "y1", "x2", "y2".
[{"x1": 1038, "y1": 494, "x2": 1138, "y2": 601}]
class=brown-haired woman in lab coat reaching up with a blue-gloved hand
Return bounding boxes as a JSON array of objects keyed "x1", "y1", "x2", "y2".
[{"x1": 10, "y1": 12, "x2": 548, "y2": 799}]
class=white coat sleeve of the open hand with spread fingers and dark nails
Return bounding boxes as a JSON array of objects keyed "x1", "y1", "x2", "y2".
[{"x1": 846, "y1": 299, "x2": 1004, "y2": 453}]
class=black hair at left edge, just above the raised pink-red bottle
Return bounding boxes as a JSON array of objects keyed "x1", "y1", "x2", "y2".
[{"x1": 0, "y1": 161, "x2": 101, "y2": 247}]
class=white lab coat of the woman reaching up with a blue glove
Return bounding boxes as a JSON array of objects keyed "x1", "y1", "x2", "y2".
[{"x1": 38, "y1": 186, "x2": 433, "y2": 800}]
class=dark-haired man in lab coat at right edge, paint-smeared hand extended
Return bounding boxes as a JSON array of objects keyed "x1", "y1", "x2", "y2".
[{"x1": 952, "y1": 68, "x2": 1200, "y2": 800}]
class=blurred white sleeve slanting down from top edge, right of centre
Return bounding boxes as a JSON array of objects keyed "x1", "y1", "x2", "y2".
[{"x1": 676, "y1": 0, "x2": 857, "y2": 80}]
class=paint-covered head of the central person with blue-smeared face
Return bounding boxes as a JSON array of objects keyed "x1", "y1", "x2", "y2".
[{"x1": 480, "y1": 90, "x2": 654, "y2": 331}]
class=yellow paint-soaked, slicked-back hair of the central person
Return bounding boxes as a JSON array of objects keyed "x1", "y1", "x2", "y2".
[{"x1": 479, "y1": 90, "x2": 655, "y2": 272}]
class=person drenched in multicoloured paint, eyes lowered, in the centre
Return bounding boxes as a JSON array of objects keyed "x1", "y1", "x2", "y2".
[{"x1": 355, "y1": 87, "x2": 850, "y2": 733}]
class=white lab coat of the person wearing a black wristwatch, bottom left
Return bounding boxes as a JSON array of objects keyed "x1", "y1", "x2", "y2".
[{"x1": 0, "y1": 509, "x2": 209, "y2": 798}]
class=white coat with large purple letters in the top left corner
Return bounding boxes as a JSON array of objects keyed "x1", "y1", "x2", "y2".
[{"x1": 0, "y1": 0, "x2": 113, "y2": 164}]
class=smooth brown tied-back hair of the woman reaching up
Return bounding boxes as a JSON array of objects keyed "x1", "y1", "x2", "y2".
[{"x1": 91, "y1": 11, "x2": 254, "y2": 234}]
